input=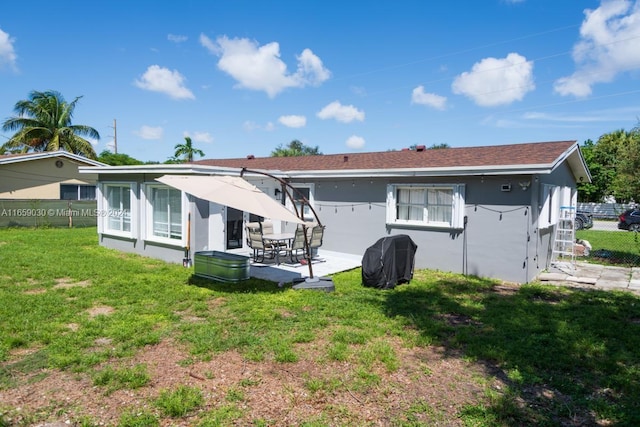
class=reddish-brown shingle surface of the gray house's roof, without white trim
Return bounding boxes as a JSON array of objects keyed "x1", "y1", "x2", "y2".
[{"x1": 193, "y1": 141, "x2": 576, "y2": 173}]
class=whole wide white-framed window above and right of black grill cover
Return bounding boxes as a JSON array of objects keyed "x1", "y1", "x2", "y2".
[{"x1": 387, "y1": 184, "x2": 464, "y2": 228}]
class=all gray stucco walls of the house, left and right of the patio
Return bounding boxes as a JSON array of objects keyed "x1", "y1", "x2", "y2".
[{"x1": 100, "y1": 169, "x2": 575, "y2": 283}]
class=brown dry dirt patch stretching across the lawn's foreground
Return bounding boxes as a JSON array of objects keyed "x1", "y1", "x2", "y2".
[{"x1": 0, "y1": 340, "x2": 503, "y2": 426}]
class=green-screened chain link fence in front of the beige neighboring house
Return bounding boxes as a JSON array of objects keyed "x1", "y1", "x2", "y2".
[{"x1": 0, "y1": 200, "x2": 99, "y2": 228}]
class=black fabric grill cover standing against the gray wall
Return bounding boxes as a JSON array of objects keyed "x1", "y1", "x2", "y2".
[{"x1": 362, "y1": 234, "x2": 418, "y2": 289}]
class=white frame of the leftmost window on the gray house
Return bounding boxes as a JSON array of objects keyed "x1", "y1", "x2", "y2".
[{"x1": 96, "y1": 182, "x2": 138, "y2": 238}]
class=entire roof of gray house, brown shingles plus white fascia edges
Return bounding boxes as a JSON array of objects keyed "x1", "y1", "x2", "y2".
[{"x1": 80, "y1": 141, "x2": 591, "y2": 182}]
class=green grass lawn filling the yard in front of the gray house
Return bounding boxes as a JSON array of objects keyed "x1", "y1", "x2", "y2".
[{"x1": 0, "y1": 228, "x2": 640, "y2": 427}]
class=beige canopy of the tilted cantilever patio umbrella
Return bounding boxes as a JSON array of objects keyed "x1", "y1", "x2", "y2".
[{"x1": 156, "y1": 175, "x2": 304, "y2": 224}]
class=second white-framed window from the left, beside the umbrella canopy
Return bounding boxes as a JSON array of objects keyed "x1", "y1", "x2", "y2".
[{"x1": 147, "y1": 186, "x2": 182, "y2": 240}]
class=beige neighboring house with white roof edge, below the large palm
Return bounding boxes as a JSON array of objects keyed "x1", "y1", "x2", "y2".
[{"x1": 0, "y1": 151, "x2": 107, "y2": 200}]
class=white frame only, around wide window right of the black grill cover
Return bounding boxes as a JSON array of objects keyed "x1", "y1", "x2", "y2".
[{"x1": 387, "y1": 184, "x2": 465, "y2": 229}]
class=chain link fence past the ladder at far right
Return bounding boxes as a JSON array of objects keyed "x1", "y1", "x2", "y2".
[{"x1": 576, "y1": 203, "x2": 640, "y2": 267}]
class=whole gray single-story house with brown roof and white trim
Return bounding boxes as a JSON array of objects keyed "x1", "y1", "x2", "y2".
[{"x1": 81, "y1": 141, "x2": 591, "y2": 283}]
